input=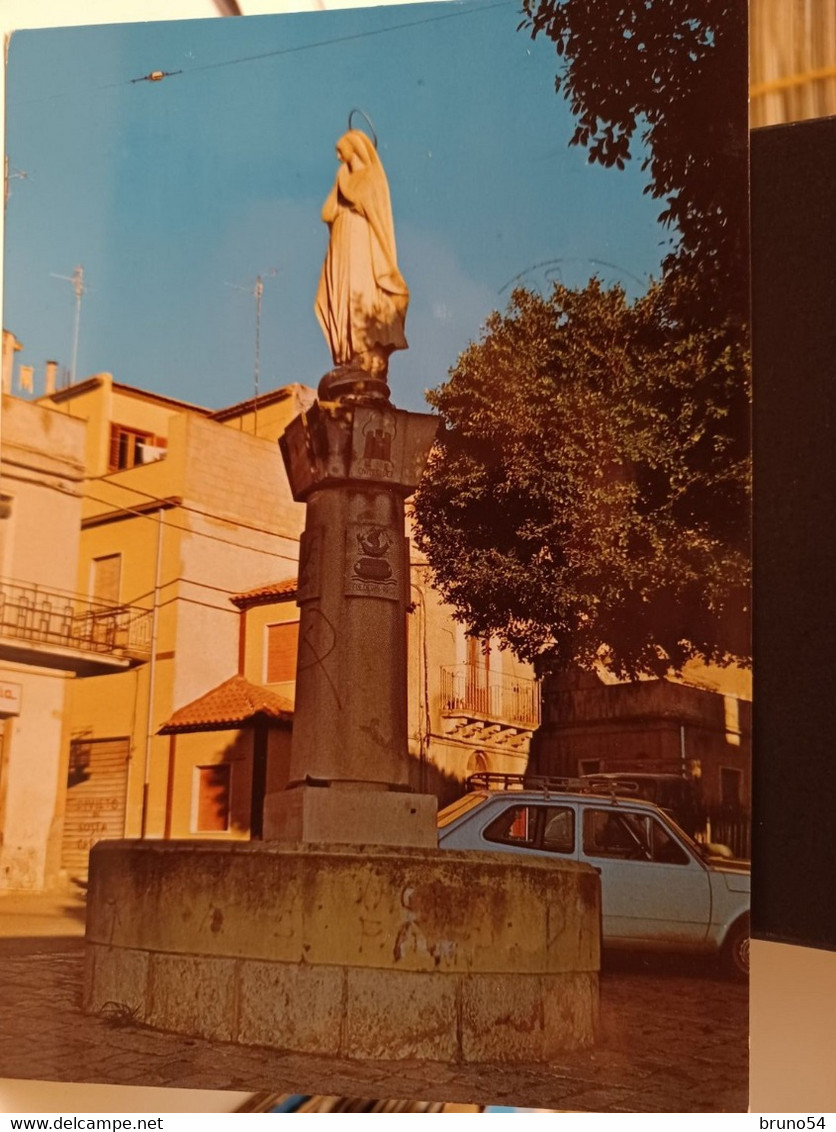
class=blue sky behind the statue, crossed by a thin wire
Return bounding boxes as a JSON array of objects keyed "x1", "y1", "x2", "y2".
[{"x1": 3, "y1": 0, "x2": 669, "y2": 410}]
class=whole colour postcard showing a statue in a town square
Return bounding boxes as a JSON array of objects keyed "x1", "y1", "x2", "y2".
[{"x1": 0, "y1": 0, "x2": 751, "y2": 1113}]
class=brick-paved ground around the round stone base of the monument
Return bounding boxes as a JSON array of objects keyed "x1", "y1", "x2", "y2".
[{"x1": 0, "y1": 893, "x2": 748, "y2": 1112}]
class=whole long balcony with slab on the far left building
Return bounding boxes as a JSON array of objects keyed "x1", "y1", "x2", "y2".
[{"x1": 0, "y1": 578, "x2": 152, "y2": 676}]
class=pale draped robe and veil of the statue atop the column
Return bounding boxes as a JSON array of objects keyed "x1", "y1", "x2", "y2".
[{"x1": 316, "y1": 130, "x2": 410, "y2": 366}]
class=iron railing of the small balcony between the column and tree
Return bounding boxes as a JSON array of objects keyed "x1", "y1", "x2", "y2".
[{"x1": 441, "y1": 664, "x2": 540, "y2": 730}]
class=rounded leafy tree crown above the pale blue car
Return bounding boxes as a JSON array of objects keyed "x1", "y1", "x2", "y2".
[{"x1": 415, "y1": 278, "x2": 749, "y2": 676}]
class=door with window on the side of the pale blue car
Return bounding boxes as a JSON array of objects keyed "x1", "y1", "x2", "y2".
[{"x1": 579, "y1": 804, "x2": 712, "y2": 947}]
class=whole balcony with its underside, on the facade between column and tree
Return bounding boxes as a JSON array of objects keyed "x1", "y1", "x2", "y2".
[{"x1": 441, "y1": 664, "x2": 540, "y2": 749}]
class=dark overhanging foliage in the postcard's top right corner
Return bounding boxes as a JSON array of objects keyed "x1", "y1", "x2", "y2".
[{"x1": 523, "y1": 0, "x2": 749, "y2": 325}]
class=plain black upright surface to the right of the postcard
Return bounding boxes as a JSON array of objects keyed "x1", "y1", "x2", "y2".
[{"x1": 751, "y1": 118, "x2": 836, "y2": 949}]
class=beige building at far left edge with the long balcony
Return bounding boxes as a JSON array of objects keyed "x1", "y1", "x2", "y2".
[{"x1": 0, "y1": 395, "x2": 150, "y2": 890}]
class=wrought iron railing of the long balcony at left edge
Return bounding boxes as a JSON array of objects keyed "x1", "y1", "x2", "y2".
[{"x1": 0, "y1": 578, "x2": 152, "y2": 660}]
